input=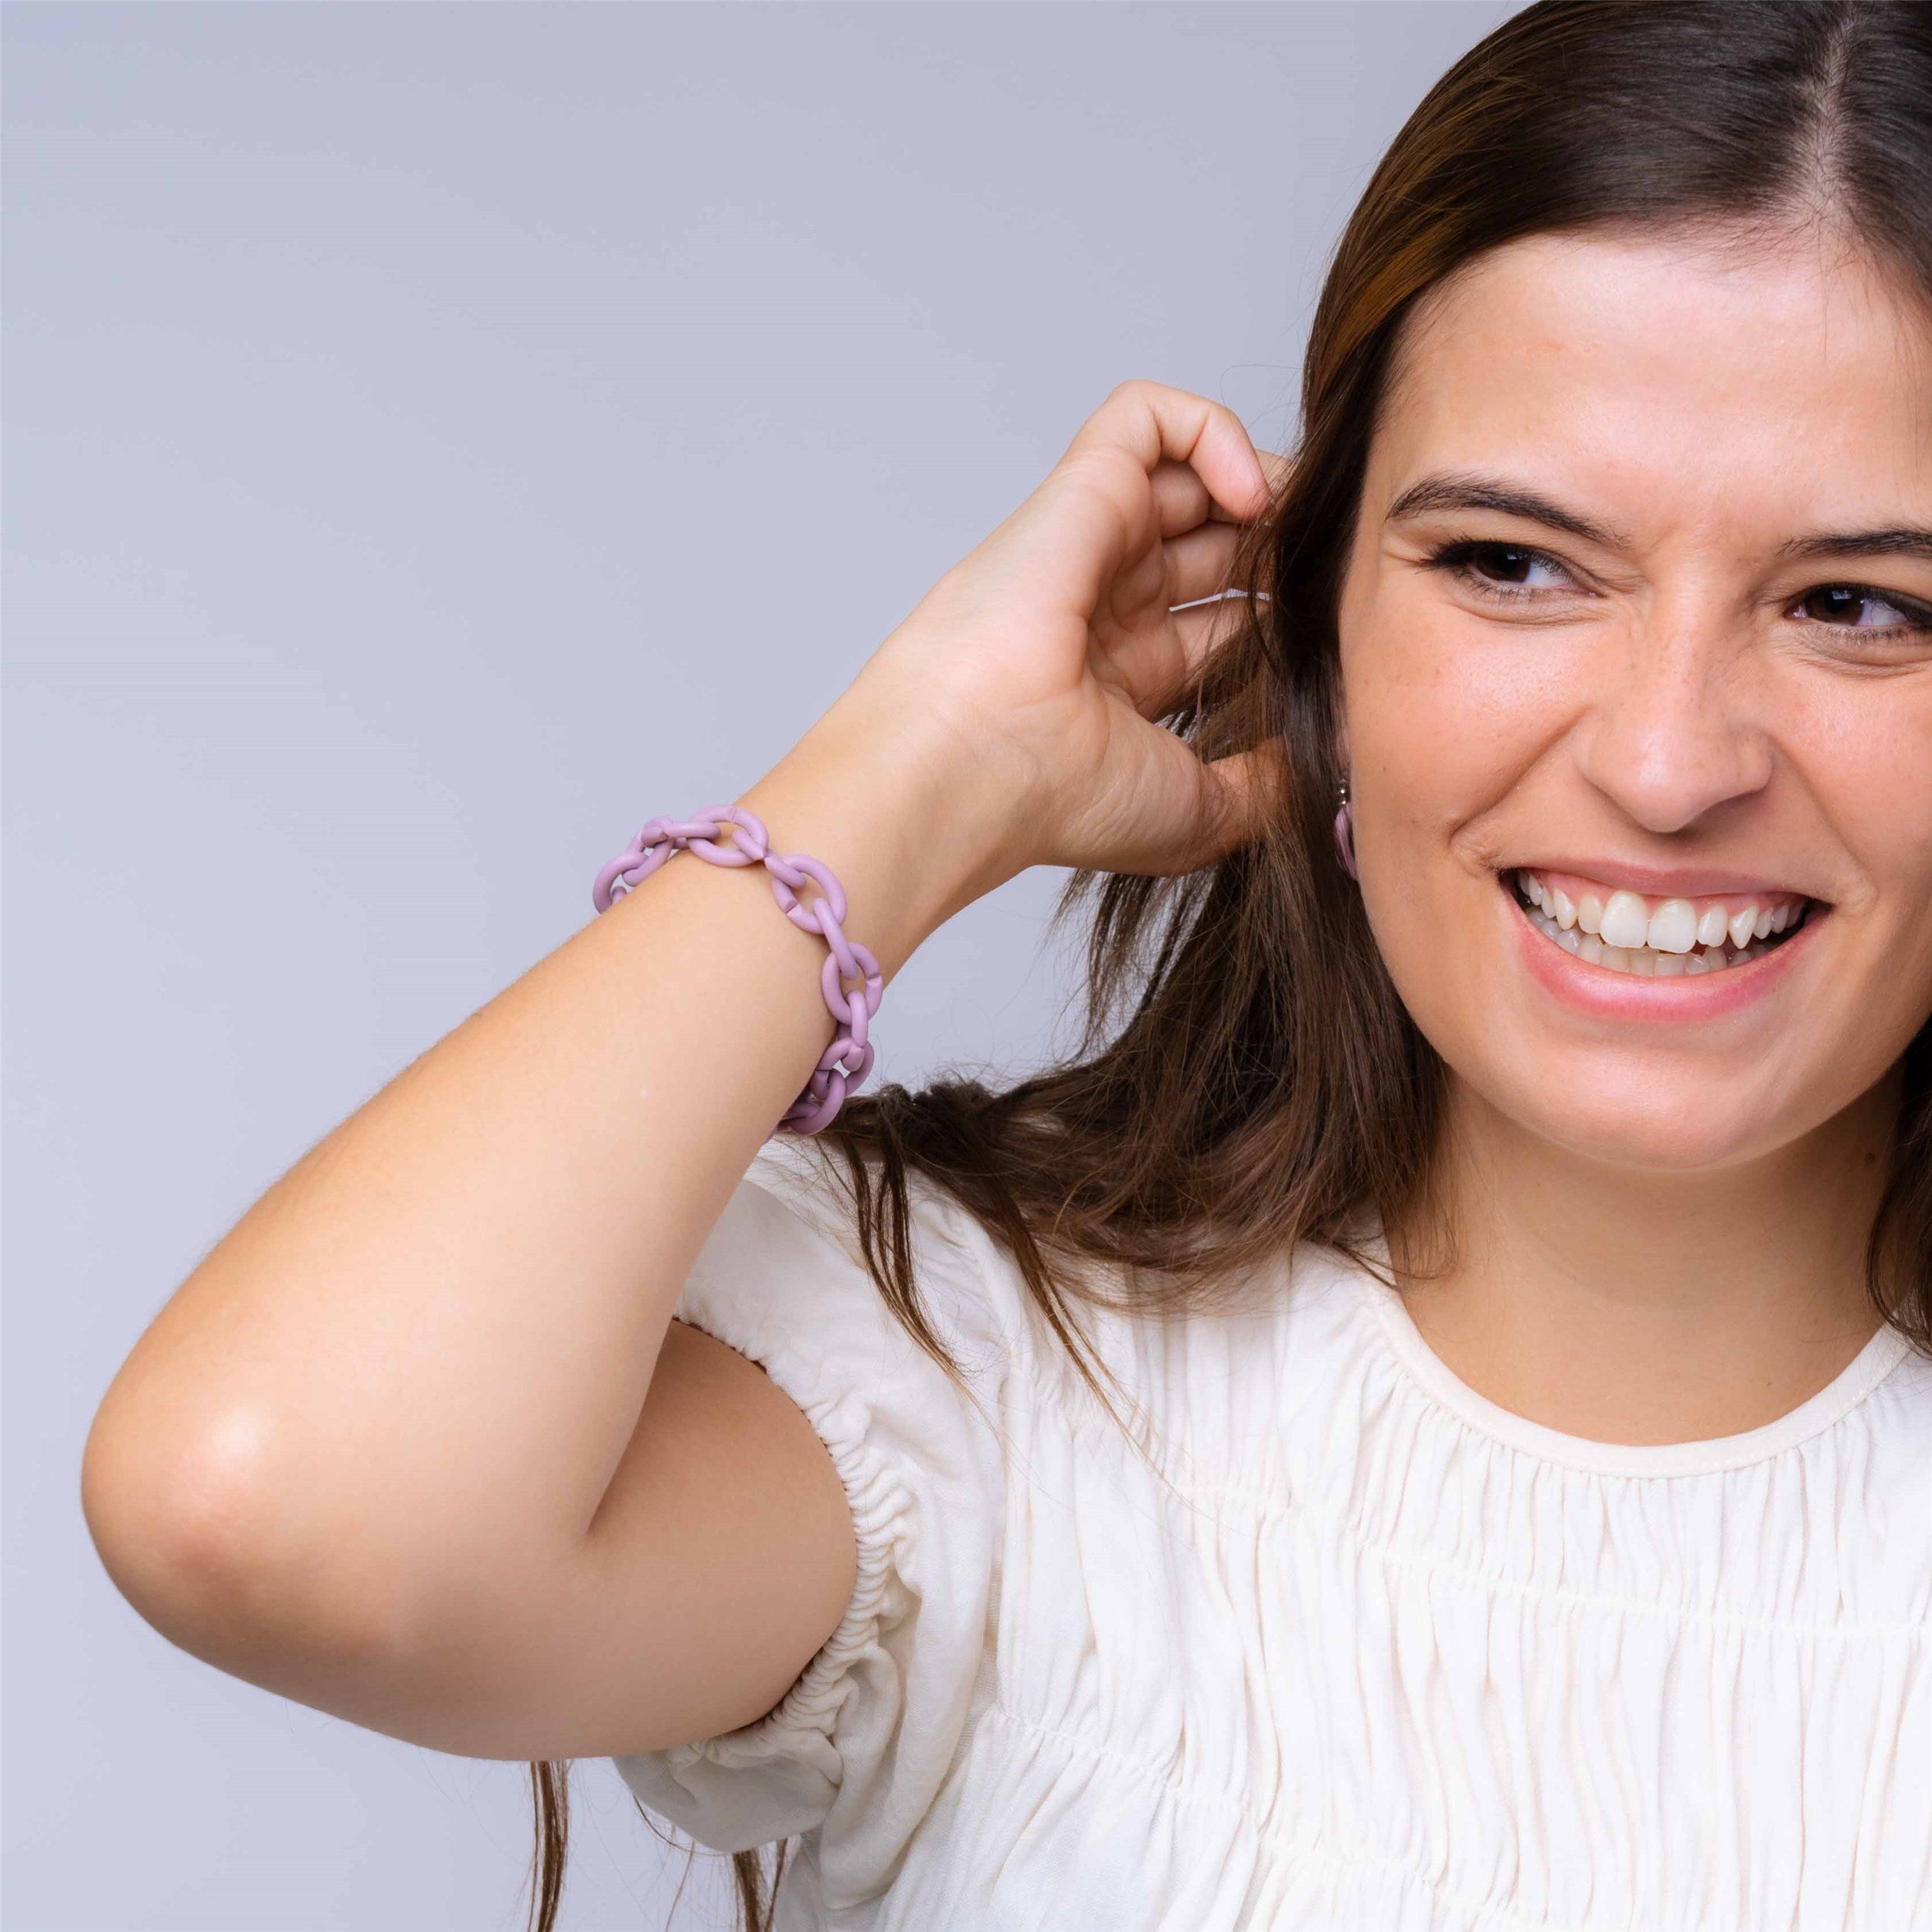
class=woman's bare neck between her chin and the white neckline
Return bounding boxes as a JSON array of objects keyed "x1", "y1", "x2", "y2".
[{"x1": 1397, "y1": 1078, "x2": 1900, "y2": 1444}]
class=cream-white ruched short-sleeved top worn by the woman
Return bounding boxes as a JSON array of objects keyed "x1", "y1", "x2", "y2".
[{"x1": 617, "y1": 1136, "x2": 1932, "y2": 1932}]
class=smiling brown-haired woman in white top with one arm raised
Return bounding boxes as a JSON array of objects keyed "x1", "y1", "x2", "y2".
[{"x1": 85, "y1": 0, "x2": 1932, "y2": 1932}]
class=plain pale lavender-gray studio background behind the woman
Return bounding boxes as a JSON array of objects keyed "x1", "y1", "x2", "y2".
[{"x1": 4, "y1": 4, "x2": 1509, "y2": 1932}]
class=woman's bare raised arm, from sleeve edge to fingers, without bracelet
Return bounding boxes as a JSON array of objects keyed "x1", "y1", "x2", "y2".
[{"x1": 83, "y1": 385, "x2": 1266, "y2": 1758}]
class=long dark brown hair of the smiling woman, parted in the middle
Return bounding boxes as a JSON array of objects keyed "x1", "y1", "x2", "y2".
[{"x1": 532, "y1": 0, "x2": 1932, "y2": 1932}]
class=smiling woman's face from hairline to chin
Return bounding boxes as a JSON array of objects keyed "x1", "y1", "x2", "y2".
[{"x1": 1341, "y1": 224, "x2": 1932, "y2": 1171}]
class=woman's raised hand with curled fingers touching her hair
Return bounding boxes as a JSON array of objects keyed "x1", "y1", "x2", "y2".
[{"x1": 835, "y1": 383, "x2": 1281, "y2": 876}]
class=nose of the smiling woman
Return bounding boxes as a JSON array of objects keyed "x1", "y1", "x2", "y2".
[{"x1": 1573, "y1": 617, "x2": 1774, "y2": 835}]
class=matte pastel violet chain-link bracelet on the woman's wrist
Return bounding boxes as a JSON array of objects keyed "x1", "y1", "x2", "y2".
[{"x1": 591, "y1": 806, "x2": 885, "y2": 1134}]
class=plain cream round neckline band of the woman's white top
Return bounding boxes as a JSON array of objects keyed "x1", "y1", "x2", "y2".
[{"x1": 1349, "y1": 1267, "x2": 1911, "y2": 1476}]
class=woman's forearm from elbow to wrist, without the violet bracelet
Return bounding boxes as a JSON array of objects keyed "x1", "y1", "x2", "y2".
[{"x1": 83, "y1": 686, "x2": 1007, "y2": 1648}]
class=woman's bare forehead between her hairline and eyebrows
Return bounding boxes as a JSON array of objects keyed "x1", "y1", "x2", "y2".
[{"x1": 1364, "y1": 230, "x2": 1932, "y2": 556}]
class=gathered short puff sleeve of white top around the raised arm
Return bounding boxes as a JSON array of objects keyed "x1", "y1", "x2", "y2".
[{"x1": 614, "y1": 1134, "x2": 1005, "y2": 1901}]
